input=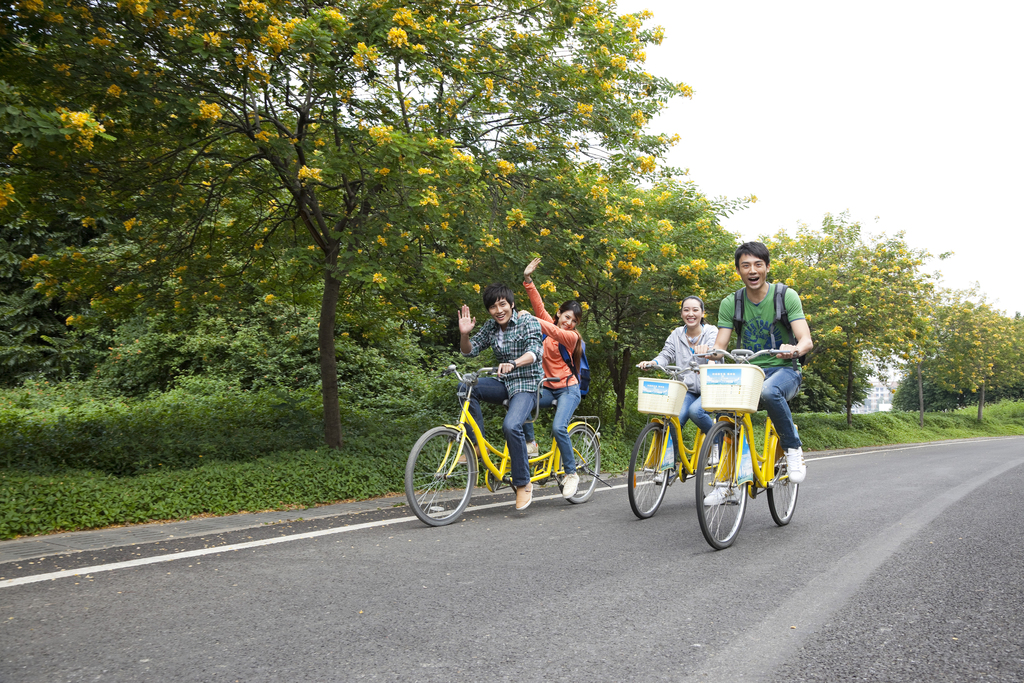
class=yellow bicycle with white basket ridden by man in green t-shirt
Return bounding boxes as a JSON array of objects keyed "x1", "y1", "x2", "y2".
[{"x1": 696, "y1": 349, "x2": 800, "y2": 550}]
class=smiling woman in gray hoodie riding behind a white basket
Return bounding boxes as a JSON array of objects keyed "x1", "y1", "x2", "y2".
[{"x1": 639, "y1": 296, "x2": 718, "y2": 434}]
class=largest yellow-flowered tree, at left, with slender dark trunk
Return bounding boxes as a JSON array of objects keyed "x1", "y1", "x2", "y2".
[{"x1": 0, "y1": 0, "x2": 689, "y2": 446}]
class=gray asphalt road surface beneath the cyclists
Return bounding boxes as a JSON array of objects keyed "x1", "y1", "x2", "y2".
[{"x1": 0, "y1": 438, "x2": 1024, "y2": 683}]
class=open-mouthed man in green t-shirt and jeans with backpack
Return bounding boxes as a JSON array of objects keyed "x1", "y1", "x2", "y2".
[{"x1": 705, "y1": 242, "x2": 814, "y2": 505}]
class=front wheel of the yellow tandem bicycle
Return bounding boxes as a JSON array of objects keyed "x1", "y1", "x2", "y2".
[{"x1": 406, "y1": 427, "x2": 476, "y2": 526}]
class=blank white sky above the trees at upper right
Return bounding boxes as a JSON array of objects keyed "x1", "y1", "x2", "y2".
[{"x1": 618, "y1": 0, "x2": 1024, "y2": 314}]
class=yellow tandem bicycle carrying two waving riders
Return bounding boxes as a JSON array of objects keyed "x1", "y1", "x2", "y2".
[{"x1": 406, "y1": 366, "x2": 601, "y2": 526}]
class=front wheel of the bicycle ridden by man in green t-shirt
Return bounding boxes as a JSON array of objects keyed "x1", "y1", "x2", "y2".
[{"x1": 696, "y1": 421, "x2": 748, "y2": 550}]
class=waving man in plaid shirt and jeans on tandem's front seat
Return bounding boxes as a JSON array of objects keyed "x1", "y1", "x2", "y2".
[{"x1": 459, "y1": 284, "x2": 544, "y2": 510}]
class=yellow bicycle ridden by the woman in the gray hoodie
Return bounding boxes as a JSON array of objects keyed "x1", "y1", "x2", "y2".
[{"x1": 626, "y1": 366, "x2": 703, "y2": 519}]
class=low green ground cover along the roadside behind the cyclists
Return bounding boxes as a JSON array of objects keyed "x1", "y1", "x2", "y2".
[{"x1": 0, "y1": 396, "x2": 1024, "y2": 539}]
